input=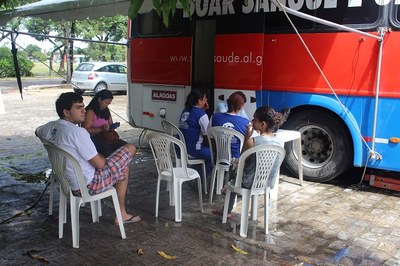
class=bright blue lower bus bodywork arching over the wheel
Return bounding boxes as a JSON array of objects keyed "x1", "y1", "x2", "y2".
[{"x1": 266, "y1": 91, "x2": 400, "y2": 174}]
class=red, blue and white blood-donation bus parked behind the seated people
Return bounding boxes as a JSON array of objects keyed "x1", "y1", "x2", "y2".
[{"x1": 127, "y1": 0, "x2": 400, "y2": 182}]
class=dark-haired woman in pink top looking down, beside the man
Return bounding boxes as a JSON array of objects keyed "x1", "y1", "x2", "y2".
[{"x1": 82, "y1": 90, "x2": 126, "y2": 158}]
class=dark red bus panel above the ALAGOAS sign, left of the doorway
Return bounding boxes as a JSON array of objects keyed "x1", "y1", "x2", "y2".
[{"x1": 129, "y1": 37, "x2": 192, "y2": 85}]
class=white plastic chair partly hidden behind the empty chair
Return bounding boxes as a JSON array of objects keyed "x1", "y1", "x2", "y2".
[{"x1": 161, "y1": 120, "x2": 208, "y2": 194}]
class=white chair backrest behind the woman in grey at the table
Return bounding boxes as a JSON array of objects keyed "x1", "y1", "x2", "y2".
[{"x1": 235, "y1": 144, "x2": 286, "y2": 189}]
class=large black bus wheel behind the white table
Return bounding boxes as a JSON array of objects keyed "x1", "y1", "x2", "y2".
[{"x1": 284, "y1": 110, "x2": 353, "y2": 182}]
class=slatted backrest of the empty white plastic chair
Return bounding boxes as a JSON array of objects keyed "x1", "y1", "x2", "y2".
[{"x1": 147, "y1": 132, "x2": 187, "y2": 178}]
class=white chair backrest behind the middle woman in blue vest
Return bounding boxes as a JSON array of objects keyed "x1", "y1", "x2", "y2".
[{"x1": 207, "y1": 126, "x2": 244, "y2": 166}]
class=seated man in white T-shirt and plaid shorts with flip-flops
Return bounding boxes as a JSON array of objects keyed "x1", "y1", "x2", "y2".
[{"x1": 36, "y1": 92, "x2": 141, "y2": 223}]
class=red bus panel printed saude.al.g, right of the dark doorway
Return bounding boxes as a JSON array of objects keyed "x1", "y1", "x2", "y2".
[{"x1": 214, "y1": 34, "x2": 264, "y2": 90}]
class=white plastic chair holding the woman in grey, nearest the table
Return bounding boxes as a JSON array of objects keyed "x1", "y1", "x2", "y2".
[{"x1": 222, "y1": 145, "x2": 286, "y2": 237}]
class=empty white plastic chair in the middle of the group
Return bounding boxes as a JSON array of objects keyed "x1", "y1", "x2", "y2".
[{"x1": 148, "y1": 133, "x2": 203, "y2": 222}]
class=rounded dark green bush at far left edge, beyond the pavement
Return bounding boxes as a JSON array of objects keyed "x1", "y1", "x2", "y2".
[{"x1": 0, "y1": 47, "x2": 33, "y2": 78}]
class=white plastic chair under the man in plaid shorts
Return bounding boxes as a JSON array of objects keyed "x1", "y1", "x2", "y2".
[{"x1": 43, "y1": 143, "x2": 126, "y2": 248}]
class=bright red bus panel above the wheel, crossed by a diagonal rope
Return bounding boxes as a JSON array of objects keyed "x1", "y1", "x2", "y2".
[{"x1": 263, "y1": 33, "x2": 394, "y2": 97}]
